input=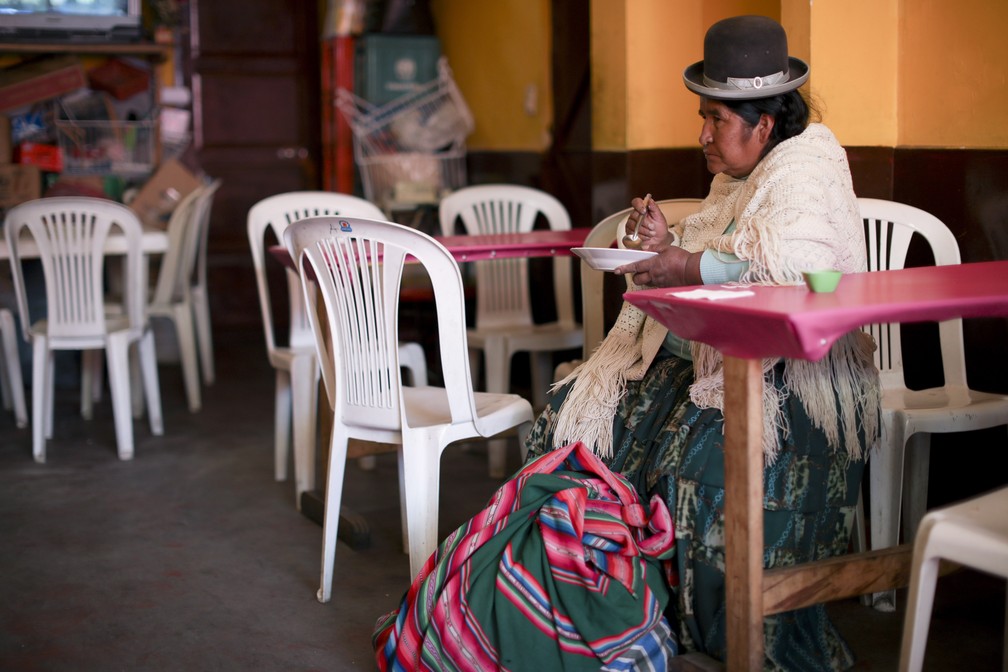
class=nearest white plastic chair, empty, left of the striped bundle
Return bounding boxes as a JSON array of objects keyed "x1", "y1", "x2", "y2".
[{"x1": 284, "y1": 217, "x2": 532, "y2": 602}]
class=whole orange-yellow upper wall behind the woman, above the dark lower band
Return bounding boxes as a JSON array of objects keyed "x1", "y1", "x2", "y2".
[{"x1": 431, "y1": 0, "x2": 1008, "y2": 151}]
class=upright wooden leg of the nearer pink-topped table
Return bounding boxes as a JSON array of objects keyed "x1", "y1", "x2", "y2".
[{"x1": 724, "y1": 357, "x2": 763, "y2": 670}]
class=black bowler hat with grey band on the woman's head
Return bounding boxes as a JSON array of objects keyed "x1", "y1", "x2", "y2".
[{"x1": 682, "y1": 16, "x2": 808, "y2": 100}]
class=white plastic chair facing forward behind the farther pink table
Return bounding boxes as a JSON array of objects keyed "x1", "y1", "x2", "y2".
[{"x1": 438, "y1": 184, "x2": 585, "y2": 478}]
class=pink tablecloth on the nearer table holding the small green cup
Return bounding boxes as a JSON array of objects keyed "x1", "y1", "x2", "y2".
[{"x1": 624, "y1": 261, "x2": 1008, "y2": 360}]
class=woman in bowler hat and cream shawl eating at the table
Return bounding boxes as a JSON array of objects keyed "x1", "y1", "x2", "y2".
[{"x1": 527, "y1": 16, "x2": 879, "y2": 670}]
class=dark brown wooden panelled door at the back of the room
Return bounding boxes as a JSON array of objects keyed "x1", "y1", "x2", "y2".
[{"x1": 181, "y1": 0, "x2": 322, "y2": 329}]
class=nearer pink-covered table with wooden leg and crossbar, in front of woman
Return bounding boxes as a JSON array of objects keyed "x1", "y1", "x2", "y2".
[{"x1": 624, "y1": 261, "x2": 1008, "y2": 670}]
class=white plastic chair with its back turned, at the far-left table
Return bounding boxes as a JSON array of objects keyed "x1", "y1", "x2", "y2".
[{"x1": 4, "y1": 196, "x2": 163, "y2": 462}]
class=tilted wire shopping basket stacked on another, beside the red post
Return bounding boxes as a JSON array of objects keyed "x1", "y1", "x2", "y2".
[{"x1": 336, "y1": 57, "x2": 474, "y2": 212}]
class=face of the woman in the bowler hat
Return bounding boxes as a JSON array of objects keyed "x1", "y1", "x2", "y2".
[{"x1": 700, "y1": 98, "x2": 773, "y2": 177}]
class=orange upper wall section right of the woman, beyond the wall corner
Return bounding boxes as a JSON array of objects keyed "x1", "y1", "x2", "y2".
[{"x1": 798, "y1": 0, "x2": 1008, "y2": 148}]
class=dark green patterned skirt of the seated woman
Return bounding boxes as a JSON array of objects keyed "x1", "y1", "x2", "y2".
[{"x1": 527, "y1": 355, "x2": 865, "y2": 671}]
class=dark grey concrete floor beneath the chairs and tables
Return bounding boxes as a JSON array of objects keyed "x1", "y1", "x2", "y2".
[{"x1": 0, "y1": 331, "x2": 1005, "y2": 671}]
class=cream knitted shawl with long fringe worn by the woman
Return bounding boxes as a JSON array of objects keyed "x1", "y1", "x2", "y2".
[{"x1": 552, "y1": 124, "x2": 879, "y2": 463}]
